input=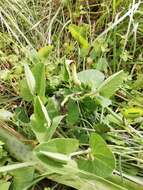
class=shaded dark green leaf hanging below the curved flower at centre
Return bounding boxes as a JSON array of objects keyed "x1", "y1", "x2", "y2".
[{"x1": 66, "y1": 99, "x2": 79, "y2": 125}]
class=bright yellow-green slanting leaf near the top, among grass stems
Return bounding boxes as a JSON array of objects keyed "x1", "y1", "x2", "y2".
[{"x1": 69, "y1": 24, "x2": 90, "y2": 48}]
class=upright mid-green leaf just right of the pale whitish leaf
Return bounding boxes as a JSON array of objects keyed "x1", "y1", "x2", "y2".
[{"x1": 33, "y1": 62, "x2": 46, "y2": 98}]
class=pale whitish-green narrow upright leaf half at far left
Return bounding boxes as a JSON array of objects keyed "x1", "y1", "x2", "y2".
[{"x1": 24, "y1": 64, "x2": 36, "y2": 95}]
